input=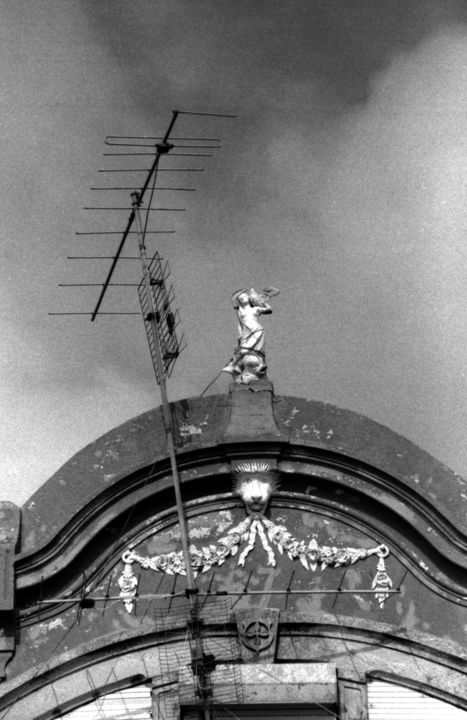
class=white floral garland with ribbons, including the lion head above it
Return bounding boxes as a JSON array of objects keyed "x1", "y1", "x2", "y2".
[{"x1": 118, "y1": 461, "x2": 392, "y2": 612}]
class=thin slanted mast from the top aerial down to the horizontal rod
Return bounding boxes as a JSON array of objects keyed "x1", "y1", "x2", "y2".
[{"x1": 131, "y1": 192, "x2": 195, "y2": 590}]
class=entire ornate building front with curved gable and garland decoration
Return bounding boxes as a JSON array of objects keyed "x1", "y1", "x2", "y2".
[{"x1": 0, "y1": 378, "x2": 467, "y2": 720}]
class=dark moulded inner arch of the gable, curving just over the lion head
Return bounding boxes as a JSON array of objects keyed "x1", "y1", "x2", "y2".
[{"x1": 16, "y1": 448, "x2": 466, "y2": 604}]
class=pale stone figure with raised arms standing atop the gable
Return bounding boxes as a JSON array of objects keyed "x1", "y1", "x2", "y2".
[{"x1": 222, "y1": 287, "x2": 279, "y2": 384}]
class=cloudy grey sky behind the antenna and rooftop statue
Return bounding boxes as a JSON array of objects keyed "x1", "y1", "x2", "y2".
[{"x1": 0, "y1": 0, "x2": 467, "y2": 505}]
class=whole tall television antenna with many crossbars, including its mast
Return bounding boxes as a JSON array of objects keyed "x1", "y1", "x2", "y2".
[{"x1": 49, "y1": 110, "x2": 236, "y2": 718}]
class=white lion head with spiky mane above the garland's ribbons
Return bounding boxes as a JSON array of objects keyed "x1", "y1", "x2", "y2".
[{"x1": 234, "y1": 461, "x2": 279, "y2": 515}]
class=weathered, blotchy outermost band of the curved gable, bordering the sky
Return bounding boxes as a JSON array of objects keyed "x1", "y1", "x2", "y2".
[{"x1": 21, "y1": 393, "x2": 467, "y2": 556}]
